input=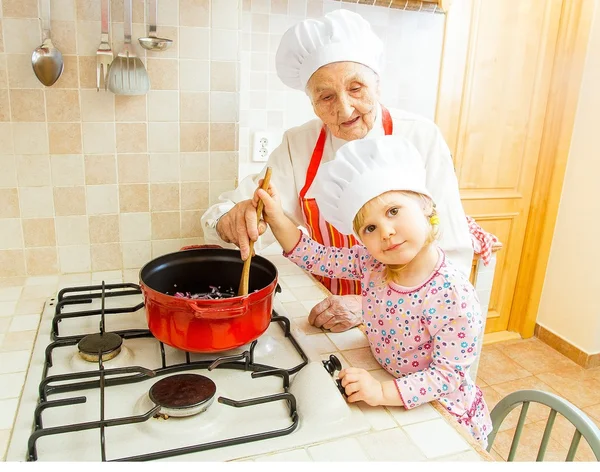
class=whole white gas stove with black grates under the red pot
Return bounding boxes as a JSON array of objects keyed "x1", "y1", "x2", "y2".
[{"x1": 7, "y1": 283, "x2": 370, "y2": 461}]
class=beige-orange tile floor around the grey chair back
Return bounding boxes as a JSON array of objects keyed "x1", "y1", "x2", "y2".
[{"x1": 477, "y1": 338, "x2": 600, "y2": 461}]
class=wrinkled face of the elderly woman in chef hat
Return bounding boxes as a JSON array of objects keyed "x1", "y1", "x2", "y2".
[{"x1": 306, "y1": 62, "x2": 379, "y2": 141}]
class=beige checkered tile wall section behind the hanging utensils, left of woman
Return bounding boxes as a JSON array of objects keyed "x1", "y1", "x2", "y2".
[{"x1": 0, "y1": 0, "x2": 241, "y2": 277}]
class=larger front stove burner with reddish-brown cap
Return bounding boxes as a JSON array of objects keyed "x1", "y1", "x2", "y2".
[{"x1": 149, "y1": 374, "x2": 217, "y2": 419}]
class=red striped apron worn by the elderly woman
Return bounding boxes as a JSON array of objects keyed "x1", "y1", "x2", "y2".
[{"x1": 300, "y1": 106, "x2": 393, "y2": 295}]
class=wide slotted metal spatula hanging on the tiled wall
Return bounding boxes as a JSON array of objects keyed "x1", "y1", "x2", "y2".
[{"x1": 108, "y1": 0, "x2": 150, "y2": 95}]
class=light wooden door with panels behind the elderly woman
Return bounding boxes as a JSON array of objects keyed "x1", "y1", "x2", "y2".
[{"x1": 436, "y1": 0, "x2": 562, "y2": 333}]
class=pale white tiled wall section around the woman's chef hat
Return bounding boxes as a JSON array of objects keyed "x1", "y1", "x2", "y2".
[{"x1": 240, "y1": 0, "x2": 445, "y2": 178}]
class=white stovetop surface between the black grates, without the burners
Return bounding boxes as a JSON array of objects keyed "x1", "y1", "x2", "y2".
[{"x1": 7, "y1": 295, "x2": 370, "y2": 461}]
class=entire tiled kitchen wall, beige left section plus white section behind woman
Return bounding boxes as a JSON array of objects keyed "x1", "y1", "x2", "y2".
[{"x1": 0, "y1": 0, "x2": 444, "y2": 277}]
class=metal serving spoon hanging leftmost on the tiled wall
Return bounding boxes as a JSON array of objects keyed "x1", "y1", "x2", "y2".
[{"x1": 31, "y1": 0, "x2": 65, "y2": 87}]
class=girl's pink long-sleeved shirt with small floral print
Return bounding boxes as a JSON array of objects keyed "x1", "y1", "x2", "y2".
[{"x1": 284, "y1": 234, "x2": 491, "y2": 443}]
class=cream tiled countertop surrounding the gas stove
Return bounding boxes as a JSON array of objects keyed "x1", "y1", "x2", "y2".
[{"x1": 0, "y1": 248, "x2": 493, "y2": 461}]
